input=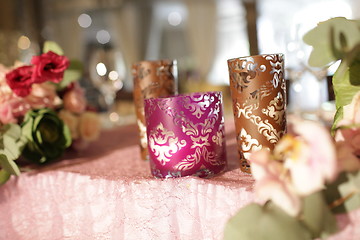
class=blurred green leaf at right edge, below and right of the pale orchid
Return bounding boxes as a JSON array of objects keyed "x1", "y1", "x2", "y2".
[{"x1": 324, "y1": 171, "x2": 360, "y2": 213}]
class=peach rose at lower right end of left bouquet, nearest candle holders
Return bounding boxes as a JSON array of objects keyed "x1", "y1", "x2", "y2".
[{"x1": 79, "y1": 112, "x2": 101, "y2": 141}]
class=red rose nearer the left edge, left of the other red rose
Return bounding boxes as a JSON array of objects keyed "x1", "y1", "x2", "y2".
[{"x1": 6, "y1": 66, "x2": 34, "y2": 97}]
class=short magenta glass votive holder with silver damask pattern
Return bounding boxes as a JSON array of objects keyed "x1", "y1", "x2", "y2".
[{"x1": 145, "y1": 92, "x2": 227, "y2": 178}]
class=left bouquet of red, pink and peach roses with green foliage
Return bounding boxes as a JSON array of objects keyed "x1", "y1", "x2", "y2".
[{"x1": 0, "y1": 42, "x2": 100, "y2": 184}]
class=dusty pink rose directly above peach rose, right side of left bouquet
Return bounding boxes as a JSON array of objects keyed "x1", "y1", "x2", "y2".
[{"x1": 63, "y1": 83, "x2": 87, "y2": 113}]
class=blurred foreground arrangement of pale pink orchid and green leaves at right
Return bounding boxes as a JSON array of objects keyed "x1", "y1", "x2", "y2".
[{"x1": 224, "y1": 18, "x2": 360, "y2": 240}]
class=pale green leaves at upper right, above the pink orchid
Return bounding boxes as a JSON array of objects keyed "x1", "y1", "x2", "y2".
[{"x1": 303, "y1": 17, "x2": 360, "y2": 130}]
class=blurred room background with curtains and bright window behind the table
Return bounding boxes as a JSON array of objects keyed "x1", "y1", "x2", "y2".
[{"x1": 0, "y1": 0, "x2": 360, "y2": 124}]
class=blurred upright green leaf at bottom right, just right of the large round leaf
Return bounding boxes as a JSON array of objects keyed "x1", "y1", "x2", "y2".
[{"x1": 302, "y1": 192, "x2": 337, "y2": 238}]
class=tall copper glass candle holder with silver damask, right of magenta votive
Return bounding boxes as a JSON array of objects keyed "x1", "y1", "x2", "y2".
[{"x1": 228, "y1": 54, "x2": 286, "y2": 173}]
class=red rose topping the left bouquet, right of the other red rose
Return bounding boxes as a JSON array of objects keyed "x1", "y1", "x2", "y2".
[{"x1": 31, "y1": 51, "x2": 70, "y2": 83}]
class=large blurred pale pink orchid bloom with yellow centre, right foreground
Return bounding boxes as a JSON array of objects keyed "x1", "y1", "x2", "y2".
[{"x1": 251, "y1": 118, "x2": 337, "y2": 216}]
